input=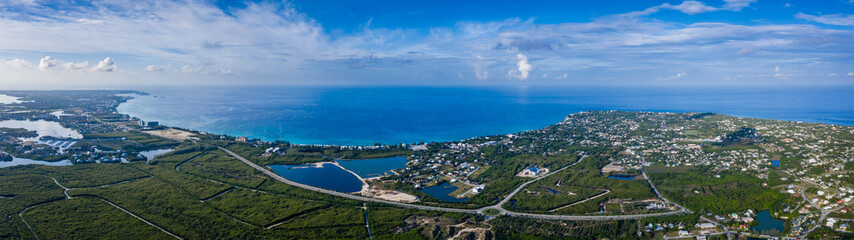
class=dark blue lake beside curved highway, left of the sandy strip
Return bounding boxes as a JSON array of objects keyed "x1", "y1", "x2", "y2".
[{"x1": 270, "y1": 163, "x2": 362, "y2": 193}]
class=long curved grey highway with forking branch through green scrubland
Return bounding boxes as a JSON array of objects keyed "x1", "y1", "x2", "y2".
[{"x1": 219, "y1": 147, "x2": 690, "y2": 221}]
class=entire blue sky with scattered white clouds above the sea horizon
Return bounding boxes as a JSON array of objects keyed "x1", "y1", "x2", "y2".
[{"x1": 0, "y1": 0, "x2": 854, "y2": 88}]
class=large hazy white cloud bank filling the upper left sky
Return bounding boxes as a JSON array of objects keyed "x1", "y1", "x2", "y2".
[{"x1": 0, "y1": 0, "x2": 328, "y2": 78}]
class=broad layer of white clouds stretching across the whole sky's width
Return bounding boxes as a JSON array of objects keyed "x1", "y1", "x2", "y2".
[{"x1": 0, "y1": 0, "x2": 854, "y2": 84}]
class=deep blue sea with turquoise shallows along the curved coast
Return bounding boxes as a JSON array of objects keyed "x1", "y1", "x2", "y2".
[{"x1": 118, "y1": 86, "x2": 854, "y2": 145}]
